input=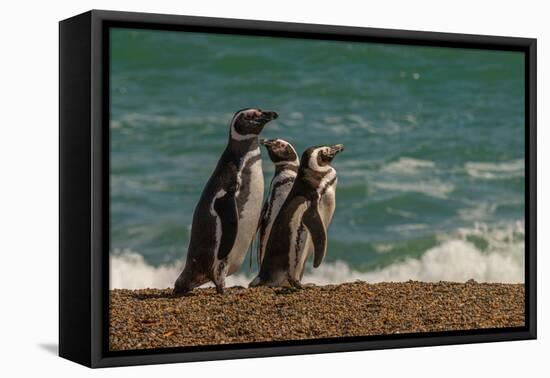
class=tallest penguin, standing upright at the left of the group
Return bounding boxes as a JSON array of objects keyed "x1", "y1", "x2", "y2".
[{"x1": 173, "y1": 108, "x2": 278, "y2": 295}]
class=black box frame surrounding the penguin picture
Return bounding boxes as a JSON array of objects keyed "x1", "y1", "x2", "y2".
[{"x1": 59, "y1": 10, "x2": 537, "y2": 367}]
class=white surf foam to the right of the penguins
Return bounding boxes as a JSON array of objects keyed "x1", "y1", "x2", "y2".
[{"x1": 304, "y1": 222, "x2": 525, "y2": 285}]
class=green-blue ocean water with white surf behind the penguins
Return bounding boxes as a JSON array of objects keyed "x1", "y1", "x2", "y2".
[{"x1": 110, "y1": 29, "x2": 525, "y2": 288}]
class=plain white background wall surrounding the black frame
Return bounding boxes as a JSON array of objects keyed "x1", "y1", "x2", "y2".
[{"x1": 0, "y1": 0, "x2": 550, "y2": 377}]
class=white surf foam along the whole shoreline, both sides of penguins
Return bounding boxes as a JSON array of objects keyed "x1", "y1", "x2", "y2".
[{"x1": 110, "y1": 222, "x2": 525, "y2": 289}]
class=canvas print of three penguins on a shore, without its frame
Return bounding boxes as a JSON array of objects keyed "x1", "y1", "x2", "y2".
[{"x1": 108, "y1": 27, "x2": 526, "y2": 351}]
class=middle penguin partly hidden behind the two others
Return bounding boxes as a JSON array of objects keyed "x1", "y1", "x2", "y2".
[{"x1": 258, "y1": 139, "x2": 300, "y2": 265}]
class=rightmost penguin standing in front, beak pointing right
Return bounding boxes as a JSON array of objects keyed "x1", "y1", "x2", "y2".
[{"x1": 249, "y1": 144, "x2": 344, "y2": 288}]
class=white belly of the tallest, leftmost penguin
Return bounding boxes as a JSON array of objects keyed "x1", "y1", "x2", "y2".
[{"x1": 227, "y1": 149, "x2": 264, "y2": 274}]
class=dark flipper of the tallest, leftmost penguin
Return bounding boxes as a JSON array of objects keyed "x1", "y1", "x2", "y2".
[{"x1": 214, "y1": 192, "x2": 239, "y2": 260}]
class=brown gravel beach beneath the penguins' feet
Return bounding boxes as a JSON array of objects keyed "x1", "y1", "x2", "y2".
[{"x1": 110, "y1": 281, "x2": 525, "y2": 350}]
